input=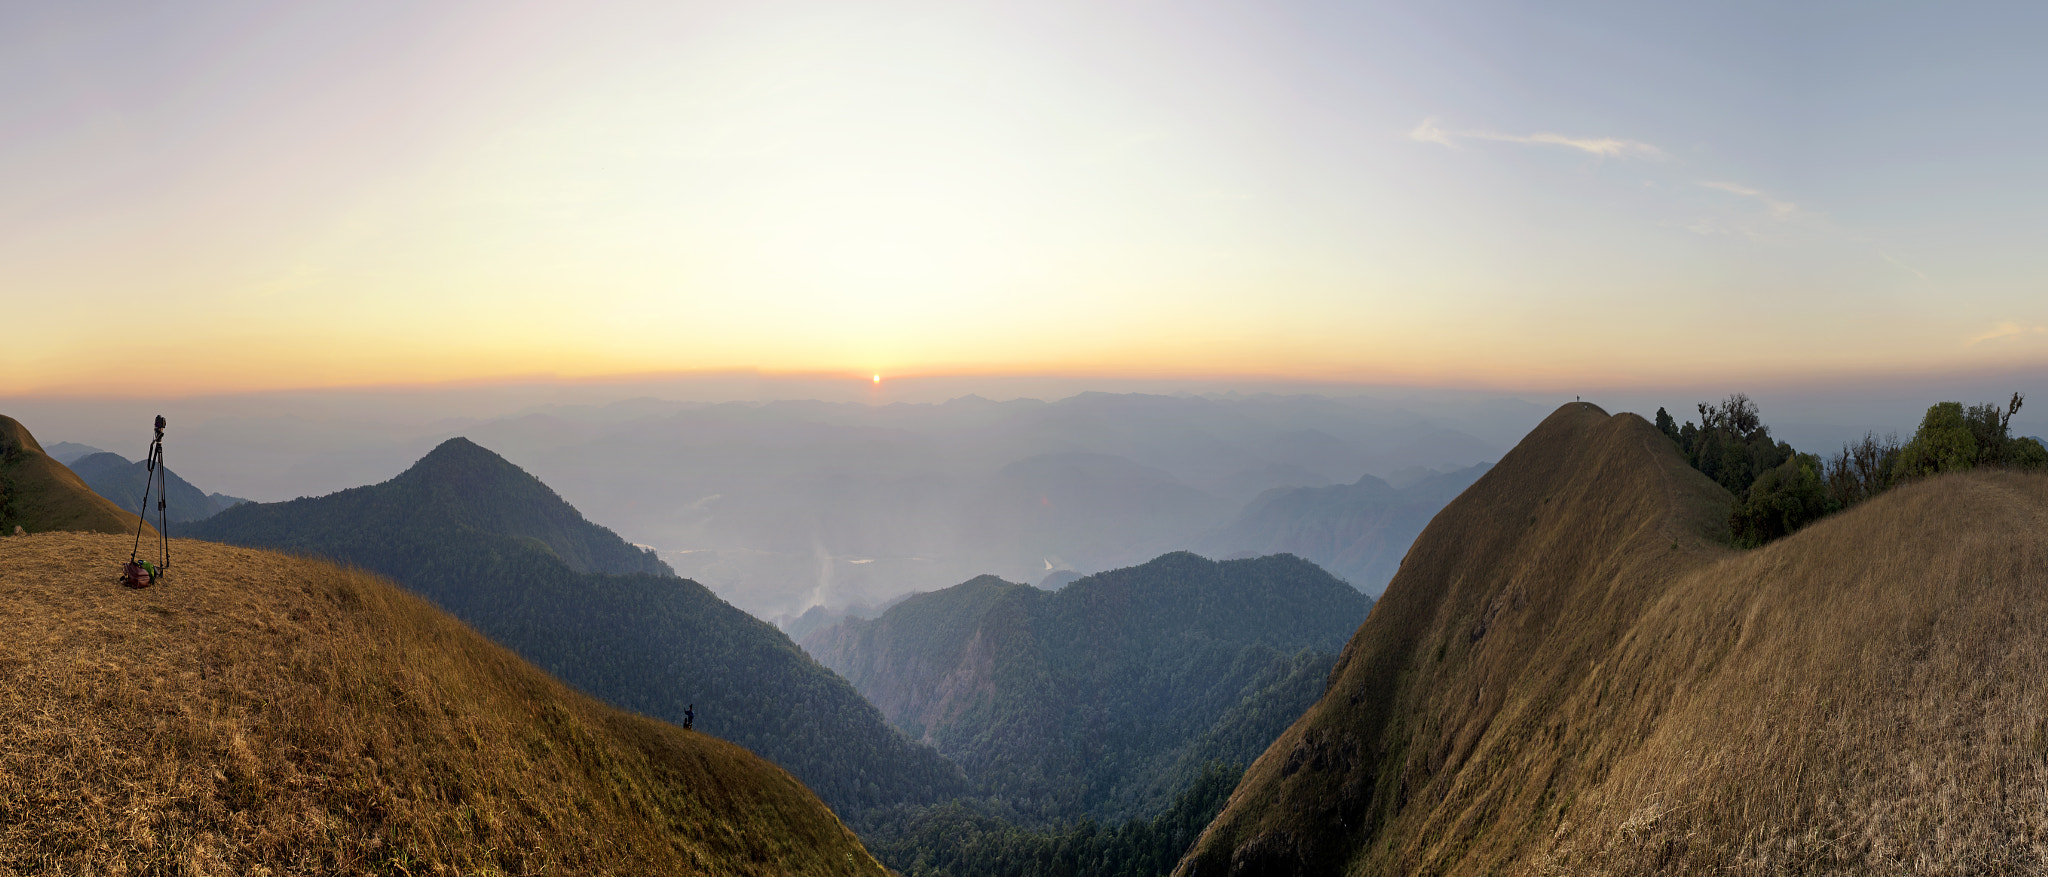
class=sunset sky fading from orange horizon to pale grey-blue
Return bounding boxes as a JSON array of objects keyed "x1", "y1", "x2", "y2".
[{"x1": 0, "y1": 0, "x2": 2048, "y2": 398}]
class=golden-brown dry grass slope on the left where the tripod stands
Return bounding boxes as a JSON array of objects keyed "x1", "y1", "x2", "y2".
[{"x1": 0, "y1": 533, "x2": 885, "y2": 875}]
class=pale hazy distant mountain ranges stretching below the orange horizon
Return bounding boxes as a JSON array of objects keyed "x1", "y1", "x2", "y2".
[{"x1": 68, "y1": 393, "x2": 1544, "y2": 621}]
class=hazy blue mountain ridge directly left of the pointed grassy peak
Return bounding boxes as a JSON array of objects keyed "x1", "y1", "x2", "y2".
[{"x1": 1196, "y1": 463, "x2": 1489, "y2": 594}]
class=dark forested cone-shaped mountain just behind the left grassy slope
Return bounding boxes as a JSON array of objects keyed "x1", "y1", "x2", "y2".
[{"x1": 193, "y1": 439, "x2": 965, "y2": 813}]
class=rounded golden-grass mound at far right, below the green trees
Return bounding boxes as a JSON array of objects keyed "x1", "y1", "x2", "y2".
[{"x1": 1544, "y1": 473, "x2": 2048, "y2": 875}]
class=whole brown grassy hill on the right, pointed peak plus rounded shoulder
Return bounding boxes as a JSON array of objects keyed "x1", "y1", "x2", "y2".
[{"x1": 1176, "y1": 404, "x2": 2048, "y2": 877}]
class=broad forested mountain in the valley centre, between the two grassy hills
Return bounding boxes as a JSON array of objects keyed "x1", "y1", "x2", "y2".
[{"x1": 805, "y1": 551, "x2": 1370, "y2": 820}]
